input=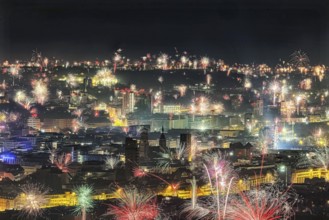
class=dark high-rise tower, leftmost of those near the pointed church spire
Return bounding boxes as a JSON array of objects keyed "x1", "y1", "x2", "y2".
[{"x1": 125, "y1": 137, "x2": 139, "y2": 179}]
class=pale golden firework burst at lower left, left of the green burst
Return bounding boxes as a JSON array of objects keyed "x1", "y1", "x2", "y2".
[{"x1": 21, "y1": 183, "x2": 48, "y2": 218}]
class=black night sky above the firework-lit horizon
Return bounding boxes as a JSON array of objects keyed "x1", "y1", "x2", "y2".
[{"x1": 0, "y1": 0, "x2": 329, "y2": 65}]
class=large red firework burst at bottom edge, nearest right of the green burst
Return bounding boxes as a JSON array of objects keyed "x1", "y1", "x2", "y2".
[{"x1": 108, "y1": 187, "x2": 159, "y2": 220}]
